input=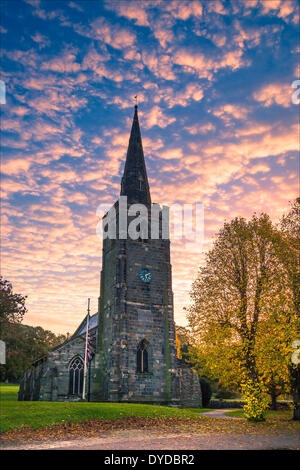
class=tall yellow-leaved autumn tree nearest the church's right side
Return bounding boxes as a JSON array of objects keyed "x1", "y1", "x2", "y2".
[{"x1": 188, "y1": 214, "x2": 278, "y2": 420}]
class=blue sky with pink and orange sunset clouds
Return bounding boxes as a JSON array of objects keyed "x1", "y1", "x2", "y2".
[{"x1": 0, "y1": 0, "x2": 300, "y2": 333}]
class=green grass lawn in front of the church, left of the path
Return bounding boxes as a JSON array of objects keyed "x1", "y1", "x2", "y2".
[{"x1": 0, "y1": 384, "x2": 208, "y2": 432}]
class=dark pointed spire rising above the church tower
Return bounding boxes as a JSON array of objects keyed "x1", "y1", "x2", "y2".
[{"x1": 121, "y1": 105, "x2": 151, "y2": 205}]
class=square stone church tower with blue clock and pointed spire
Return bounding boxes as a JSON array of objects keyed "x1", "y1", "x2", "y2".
[{"x1": 95, "y1": 106, "x2": 178, "y2": 403}]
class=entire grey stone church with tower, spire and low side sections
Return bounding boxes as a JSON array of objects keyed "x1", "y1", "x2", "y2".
[{"x1": 18, "y1": 105, "x2": 201, "y2": 407}]
